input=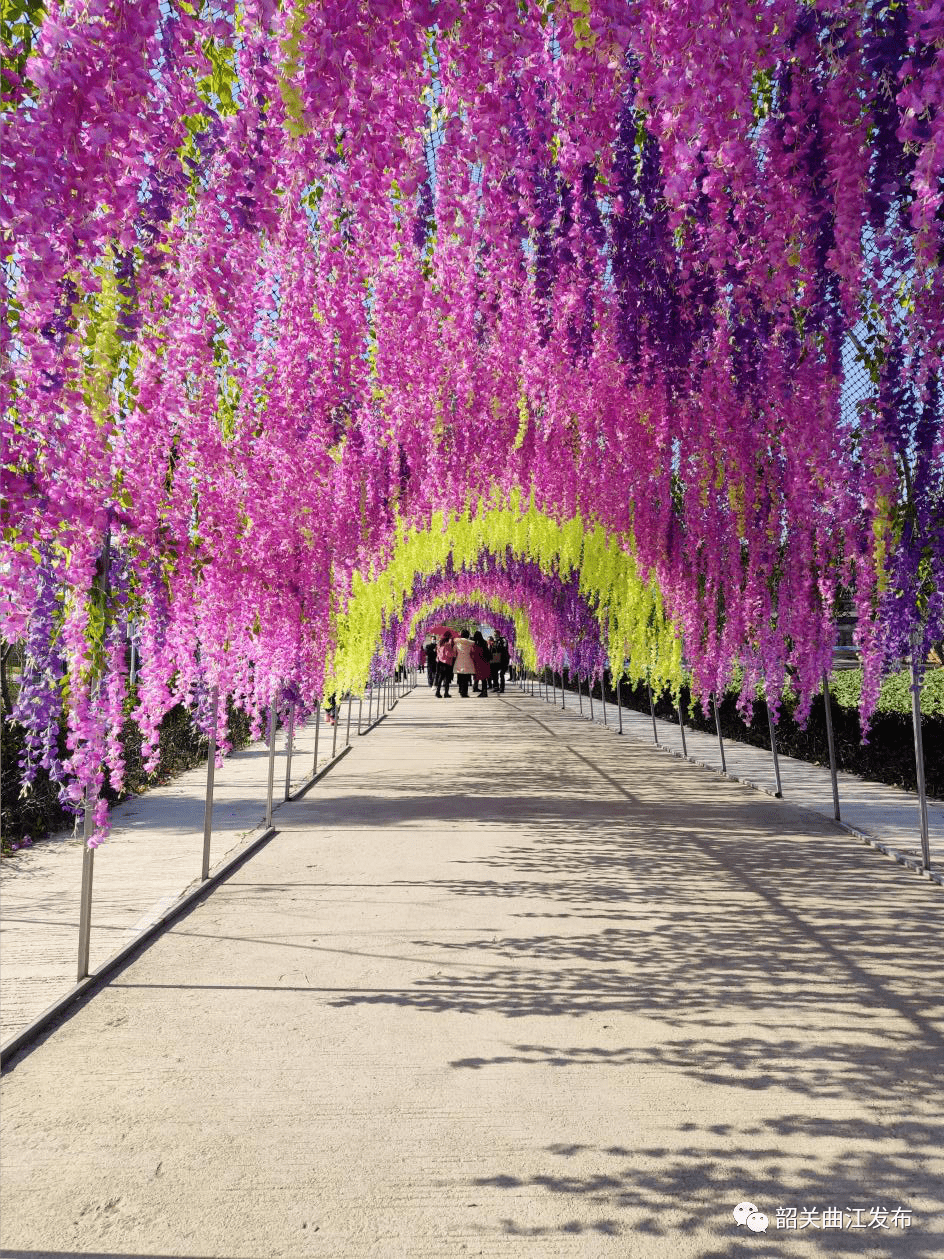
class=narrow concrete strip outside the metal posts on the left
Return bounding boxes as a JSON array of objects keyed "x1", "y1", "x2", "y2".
[{"x1": 0, "y1": 702, "x2": 378, "y2": 1045}]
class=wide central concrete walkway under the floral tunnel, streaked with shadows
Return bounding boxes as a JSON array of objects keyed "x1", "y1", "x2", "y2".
[{"x1": 0, "y1": 689, "x2": 944, "y2": 1257}]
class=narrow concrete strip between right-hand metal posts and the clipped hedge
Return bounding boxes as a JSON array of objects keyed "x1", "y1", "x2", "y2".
[{"x1": 534, "y1": 685, "x2": 944, "y2": 883}]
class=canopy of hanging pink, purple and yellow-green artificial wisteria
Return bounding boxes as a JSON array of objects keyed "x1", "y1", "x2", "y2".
[{"x1": 0, "y1": 0, "x2": 944, "y2": 837}]
